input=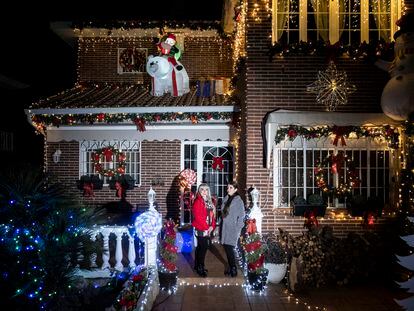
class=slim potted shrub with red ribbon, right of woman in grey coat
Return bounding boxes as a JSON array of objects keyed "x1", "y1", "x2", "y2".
[{"x1": 243, "y1": 219, "x2": 269, "y2": 291}]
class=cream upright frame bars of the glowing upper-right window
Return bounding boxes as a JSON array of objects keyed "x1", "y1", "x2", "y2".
[{"x1": 272, "y1": 0, "x2": 403, "y2": 44}]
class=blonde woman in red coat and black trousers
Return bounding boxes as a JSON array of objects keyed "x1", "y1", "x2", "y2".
[{"x1": 192, "y1": 184, "x2": 216, "y2": 277}]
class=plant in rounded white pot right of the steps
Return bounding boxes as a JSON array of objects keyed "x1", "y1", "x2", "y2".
[{"x1": 263, "y1": 233, "x2": 287, "y2": 284}]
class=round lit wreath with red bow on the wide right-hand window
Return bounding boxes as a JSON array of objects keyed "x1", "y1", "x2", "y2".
[{"x1": 315, "y1": 152, "x2": 360, "y2": 196}]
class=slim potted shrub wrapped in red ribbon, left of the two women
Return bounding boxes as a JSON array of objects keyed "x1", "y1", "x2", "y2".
[{"x1": 158, "y1": 220, "x2": 178, "y2": 291}]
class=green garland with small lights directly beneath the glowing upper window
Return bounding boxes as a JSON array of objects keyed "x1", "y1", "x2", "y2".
[{"x1": 268, "y1": 40, "x2": 394, "y2": 61}]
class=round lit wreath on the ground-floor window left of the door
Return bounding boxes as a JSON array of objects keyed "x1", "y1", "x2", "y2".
[{"x1": 91, "y1": 147, "x2": 126, "y2": 177}]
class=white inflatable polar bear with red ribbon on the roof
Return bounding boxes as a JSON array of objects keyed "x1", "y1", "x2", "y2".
[{"x1": 147, "y1": 55, "x2": 190, "y2": 96}]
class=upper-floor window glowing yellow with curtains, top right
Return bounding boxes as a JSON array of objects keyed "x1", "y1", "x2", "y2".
[{"x1": 272, "y1": 0, "x2": 402, "y2": 44}]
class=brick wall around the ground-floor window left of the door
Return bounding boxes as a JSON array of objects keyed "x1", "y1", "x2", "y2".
[{"x1": 47, "y1": 141, "x2": 181, "y2": 223}]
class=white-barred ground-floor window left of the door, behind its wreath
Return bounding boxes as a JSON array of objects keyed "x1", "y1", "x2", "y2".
[{"x1": 79, "y1": 141, "x2": 141, "y2": 185}]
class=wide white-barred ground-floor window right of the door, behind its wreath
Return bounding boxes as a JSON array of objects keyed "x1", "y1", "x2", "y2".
[{"x1": 274, "y1": 138, "x2": 392, "y2": 207}]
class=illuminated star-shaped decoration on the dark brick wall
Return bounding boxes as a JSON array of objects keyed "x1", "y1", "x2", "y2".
[{"x1": 306, "y1": 61, "x2": 356, "y2": 111}]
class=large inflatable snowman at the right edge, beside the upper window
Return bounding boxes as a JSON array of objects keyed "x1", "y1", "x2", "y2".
[{"x1": 376, "y1": 13, "x2": 414, "y2": 121}]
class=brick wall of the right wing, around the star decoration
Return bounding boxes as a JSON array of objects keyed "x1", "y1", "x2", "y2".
[{"x1": 242, "y1": 0, "x2": 389, "y2": 233}]
